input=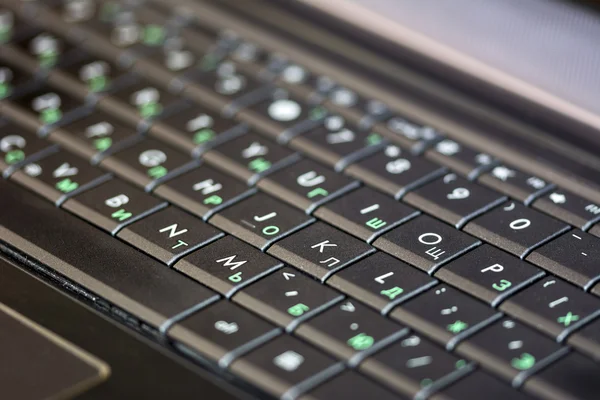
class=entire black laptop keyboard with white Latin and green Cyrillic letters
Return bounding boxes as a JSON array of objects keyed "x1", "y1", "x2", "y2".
[{"x1": 0, "y1": 0, "x2": 600, "y2": 400}]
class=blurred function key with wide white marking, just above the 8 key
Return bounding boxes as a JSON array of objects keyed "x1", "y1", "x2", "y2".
[{"x1": 375, "y1": 115, "x2": 440, "y2": 154}]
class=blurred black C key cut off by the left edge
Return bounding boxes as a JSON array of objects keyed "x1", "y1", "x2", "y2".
[{"x1": 0, "y1": 122, "x2": 52, "y2": 178}]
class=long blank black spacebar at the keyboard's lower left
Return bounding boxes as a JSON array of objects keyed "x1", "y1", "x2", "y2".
[{"x1": 0, "y1": 180, "x2": 216, "y2": 327}]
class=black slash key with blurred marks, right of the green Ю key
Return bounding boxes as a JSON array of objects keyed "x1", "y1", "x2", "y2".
[{"x1": 359, "y1": 334, "x2": 472, "y2": 398}]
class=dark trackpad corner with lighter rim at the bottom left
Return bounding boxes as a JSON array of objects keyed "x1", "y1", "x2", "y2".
[{"x1": 0, "y1": 303, "x2": 110, "y2": 400}]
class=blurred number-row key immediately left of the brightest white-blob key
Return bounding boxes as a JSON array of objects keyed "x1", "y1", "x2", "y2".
[{"x1": 183, "y1": 61, "x2": 273, "y2": 116}]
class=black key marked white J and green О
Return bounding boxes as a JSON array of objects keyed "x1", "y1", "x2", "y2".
[{"x1": 210, "y1": 193, "x2": 315, "y2": 250}]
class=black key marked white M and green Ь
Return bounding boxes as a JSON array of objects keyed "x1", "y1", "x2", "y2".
[{"x1": 174, "y1": 236, "x2": 283, "y2": 297}]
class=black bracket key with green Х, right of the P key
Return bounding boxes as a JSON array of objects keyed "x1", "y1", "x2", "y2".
[{"x1": 500, "y1": 277, "x2": 600, "y2": 342}]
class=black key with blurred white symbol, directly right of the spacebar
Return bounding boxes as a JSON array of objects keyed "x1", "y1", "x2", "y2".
[{"x1": 167, "y1": 300, "x2": 278, "y2": 367}]
